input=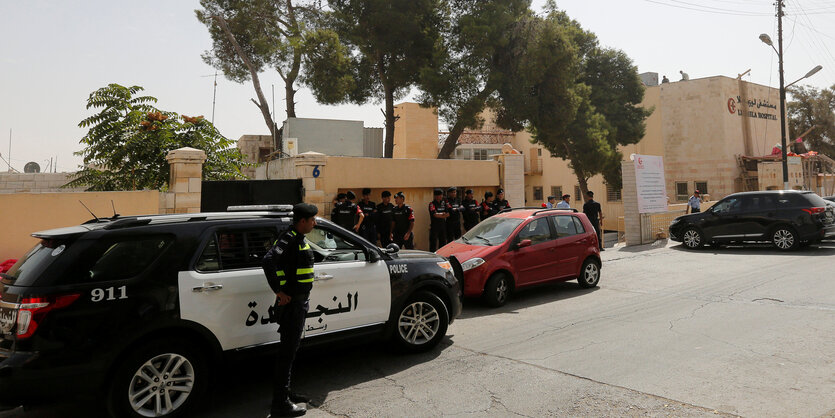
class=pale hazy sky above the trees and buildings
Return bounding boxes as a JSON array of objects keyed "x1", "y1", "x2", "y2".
[{"x1": 0, "y1": 0, "x2": 835, "y2": 171}]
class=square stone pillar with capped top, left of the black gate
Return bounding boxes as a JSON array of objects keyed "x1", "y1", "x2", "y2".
[{"x1": 162, "y1": 147, "x2": 206, "y2": 213}]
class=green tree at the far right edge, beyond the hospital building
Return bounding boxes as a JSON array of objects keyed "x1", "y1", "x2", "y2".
[{"x1": 787, "y1": 86, "x2": 835, "y2": 158}]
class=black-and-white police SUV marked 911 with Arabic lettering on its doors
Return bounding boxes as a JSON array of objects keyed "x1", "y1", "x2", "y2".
[{"x1": 0, "y1": 206, "x2": 463, "y2": 417}]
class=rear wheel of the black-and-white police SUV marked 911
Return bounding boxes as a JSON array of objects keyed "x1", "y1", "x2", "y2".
[{"x1": 108, "y1": 341, "x2": 208, "y2": 417}]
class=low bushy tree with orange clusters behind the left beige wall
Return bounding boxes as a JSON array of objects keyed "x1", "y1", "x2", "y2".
[{"x1": 65, "y1": 84, "x2": 246, "y2": 191}]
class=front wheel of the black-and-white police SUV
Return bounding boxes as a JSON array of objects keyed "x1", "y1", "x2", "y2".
[{"x1": 394, "y1": 292, "x2": 449, "y2": 352}]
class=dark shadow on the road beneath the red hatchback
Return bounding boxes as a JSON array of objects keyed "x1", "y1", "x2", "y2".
[{"x1": 458, "y1": 280, "x2": 606, "y2": 319}]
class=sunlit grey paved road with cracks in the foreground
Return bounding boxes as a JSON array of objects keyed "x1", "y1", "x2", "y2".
[{"x1": 6, "y1": 243, "x2": 835, "y2": 417}]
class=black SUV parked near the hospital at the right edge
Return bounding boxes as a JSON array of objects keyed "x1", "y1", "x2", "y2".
[{"x1": 670, "y1": 190, "x2": 835, "y2": 251}]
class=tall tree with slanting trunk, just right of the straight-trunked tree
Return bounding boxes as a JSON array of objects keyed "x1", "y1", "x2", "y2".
[{"x1": 420, "y1": 0, "x2": 531, "y2": 158}]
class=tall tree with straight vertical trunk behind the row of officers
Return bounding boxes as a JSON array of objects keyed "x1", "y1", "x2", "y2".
[{"x1": 309, "y1": 0, "x2": 447, "y2": 158}]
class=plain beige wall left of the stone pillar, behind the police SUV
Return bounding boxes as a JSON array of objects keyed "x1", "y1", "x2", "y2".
[{"x1": 0, "y1": 190, "x2": 159, "y2": 262}]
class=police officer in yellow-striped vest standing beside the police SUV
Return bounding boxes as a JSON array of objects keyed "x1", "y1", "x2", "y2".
[{"x1": 262, "y1": 203, "x2": 319, "y2": 417}]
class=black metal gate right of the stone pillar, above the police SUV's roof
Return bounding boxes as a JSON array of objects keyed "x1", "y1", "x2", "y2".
[{"x1": 200, "y1": 179, "x2": 304, "y2": 212}]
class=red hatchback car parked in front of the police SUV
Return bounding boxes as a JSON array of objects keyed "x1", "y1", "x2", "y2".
[{"x1": 437, "y1": 208, "x2": 601, "y2": 307}]
